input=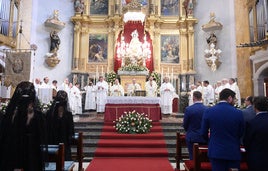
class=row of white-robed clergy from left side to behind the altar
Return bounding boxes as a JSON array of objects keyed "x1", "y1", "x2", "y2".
[{"x1": 34, "y1": 76, "x2": 178, "y2": 115}]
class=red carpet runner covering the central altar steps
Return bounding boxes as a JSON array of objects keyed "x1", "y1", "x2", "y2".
[{"x1": 86, "y1": 122, "x2": 174, "y2": 171}]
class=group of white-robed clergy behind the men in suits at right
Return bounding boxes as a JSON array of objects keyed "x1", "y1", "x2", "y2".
[{"x1": 188, "y1": 78, "x2": 241, "y2": 107}]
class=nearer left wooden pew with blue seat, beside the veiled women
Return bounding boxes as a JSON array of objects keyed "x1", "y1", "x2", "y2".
[{"x1": 42, "y1": 143, "x2": 75, "y2": 171}]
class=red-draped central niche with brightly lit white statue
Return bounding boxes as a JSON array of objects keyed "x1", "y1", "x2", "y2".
[{"x1": 114, "y1": 21, "x2": 154, "y2": 72}]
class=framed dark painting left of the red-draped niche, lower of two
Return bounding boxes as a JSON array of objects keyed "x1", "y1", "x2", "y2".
[{"x1": 88, "y1": 34, "x2": 108, "y2": 62}]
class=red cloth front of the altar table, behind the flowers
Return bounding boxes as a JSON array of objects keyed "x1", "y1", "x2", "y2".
[{"x1": 104, "y1": 104, "x2": 162, "y2": 122}]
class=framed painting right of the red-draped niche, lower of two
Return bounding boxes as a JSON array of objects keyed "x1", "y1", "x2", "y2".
[{"x1": 161, "y1": 35, "x2": 180, "y2": 63}]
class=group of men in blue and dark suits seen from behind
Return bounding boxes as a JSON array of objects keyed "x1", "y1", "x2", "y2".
[{"x1": 183, "y1": 88, "x2": 268, "y2": 171}]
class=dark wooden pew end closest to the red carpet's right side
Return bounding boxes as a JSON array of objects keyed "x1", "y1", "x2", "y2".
[{"x1": 175, "y1": 131, "x2": 189, "y2": 171}]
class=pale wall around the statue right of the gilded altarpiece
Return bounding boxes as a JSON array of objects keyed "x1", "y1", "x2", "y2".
[{"x1": 194, "y1": 0, "x2": 237, "y2": 84}]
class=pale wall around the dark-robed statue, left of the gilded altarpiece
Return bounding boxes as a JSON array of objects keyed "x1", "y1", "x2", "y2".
[{"x1": 30, "y1": 0, "x2": 74, "y2": 83}]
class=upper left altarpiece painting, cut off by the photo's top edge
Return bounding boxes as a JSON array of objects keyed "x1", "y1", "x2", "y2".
[{"x1": 90, "y1": 0, "x2": 109, "y2": 15}]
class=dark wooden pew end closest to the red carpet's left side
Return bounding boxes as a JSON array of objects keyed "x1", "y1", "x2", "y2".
[{"x1": 72, "y1": 132, "x2": 84, "y2": 171}]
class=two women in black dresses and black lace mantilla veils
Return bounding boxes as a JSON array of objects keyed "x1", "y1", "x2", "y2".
[{"x1": 0, "y1": 81, "x2": 74, "y2": 171}]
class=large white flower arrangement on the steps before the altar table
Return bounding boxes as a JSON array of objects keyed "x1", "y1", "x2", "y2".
[{"x1": 114, "y1": 111, "x2": 152, "y2": 134}]
